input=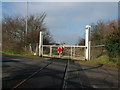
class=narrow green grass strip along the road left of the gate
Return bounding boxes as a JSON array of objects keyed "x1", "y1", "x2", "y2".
[{"x1": 0, "y1": 51, "x2": 39, "y2": 58}]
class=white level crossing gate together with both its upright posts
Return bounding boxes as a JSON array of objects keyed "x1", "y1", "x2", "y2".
[{"x1": 39, "y1": 25, "x2": 91, "y2": 61}]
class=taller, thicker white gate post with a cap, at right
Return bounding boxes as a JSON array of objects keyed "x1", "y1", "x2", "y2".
[{"x1": 85, "y1": 25, "x2": 91, "y2": 61}]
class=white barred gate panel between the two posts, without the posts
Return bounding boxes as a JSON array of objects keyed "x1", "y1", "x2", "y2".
[{"x1": 42, "y1": 45, "x2": 86, "y2": 60}]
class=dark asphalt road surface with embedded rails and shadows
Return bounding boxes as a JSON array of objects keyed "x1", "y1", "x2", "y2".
[{"x1": 2, "y1": 54, "x2": 118, "y2": 90}]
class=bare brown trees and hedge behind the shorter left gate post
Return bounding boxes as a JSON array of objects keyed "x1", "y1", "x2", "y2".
[{"x1": 2, "y1": 13, "x2": 53, "y2": 52}]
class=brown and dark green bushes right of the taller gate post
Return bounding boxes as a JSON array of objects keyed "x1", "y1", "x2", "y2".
[{"x1": 79, "y1": 20, "x2": 120, "y2": 57}]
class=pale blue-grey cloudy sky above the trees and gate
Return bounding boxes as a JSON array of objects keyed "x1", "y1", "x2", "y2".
[{"x1": 2, "y1": 2, "x2": 118, "y2": 44}]
